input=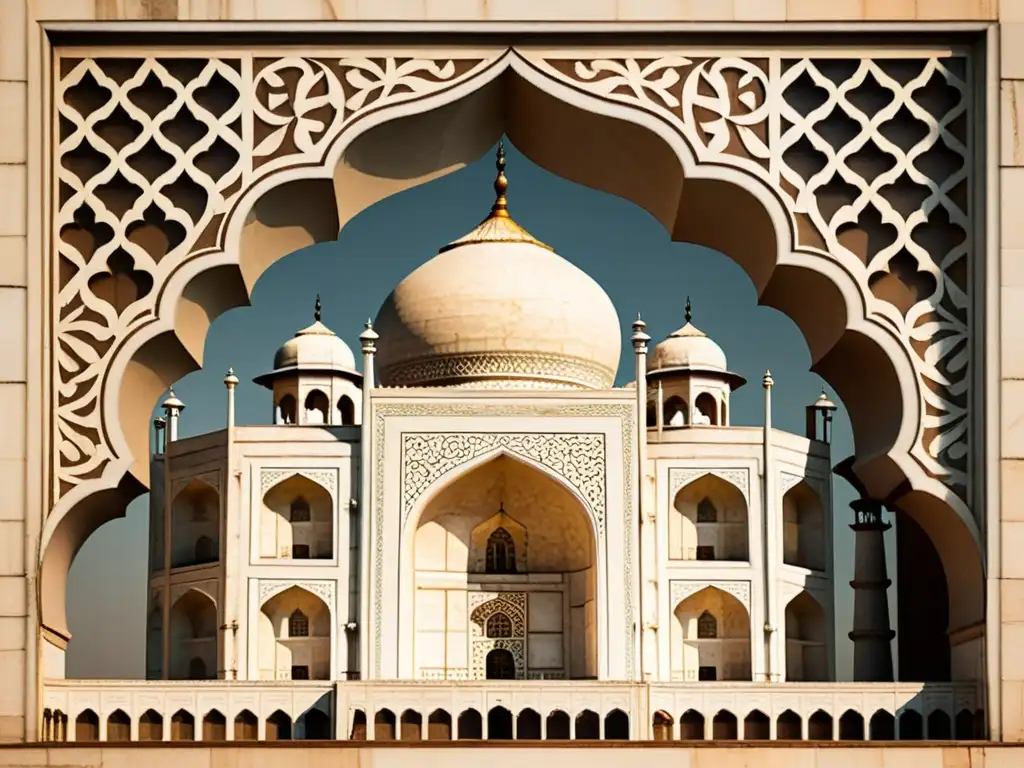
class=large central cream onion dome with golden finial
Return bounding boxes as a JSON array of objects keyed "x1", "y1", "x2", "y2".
[{"x1": 374, "y1": 143, "x2": 622, "y2": 389}]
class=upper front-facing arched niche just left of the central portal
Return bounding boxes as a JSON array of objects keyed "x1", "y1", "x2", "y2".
[{"x1": 259, "y1": 472, "x2": 334, "y2": 560}]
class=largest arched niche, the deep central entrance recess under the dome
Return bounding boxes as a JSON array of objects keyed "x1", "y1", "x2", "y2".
[{"x1": 403, "y1": 454, "x2": 600, "y2": 679}]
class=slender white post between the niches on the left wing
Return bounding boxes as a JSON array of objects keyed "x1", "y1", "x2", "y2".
[{"x1": 223, "y1": 368, "x2": 240, "y2": 680}]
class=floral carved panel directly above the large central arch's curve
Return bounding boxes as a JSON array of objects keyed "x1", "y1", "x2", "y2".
[{"x1": 401, "y1": 432, "x2": 605, "y2": 534}]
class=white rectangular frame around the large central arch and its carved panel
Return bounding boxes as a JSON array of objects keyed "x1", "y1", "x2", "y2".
[{"x1": 360, "y1": 397, "x2": 639, "y2": 680}]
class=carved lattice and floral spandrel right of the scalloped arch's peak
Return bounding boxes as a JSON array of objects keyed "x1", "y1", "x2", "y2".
[{"x1": 538, "y1": 55, "x2": 973, "y2": 498}]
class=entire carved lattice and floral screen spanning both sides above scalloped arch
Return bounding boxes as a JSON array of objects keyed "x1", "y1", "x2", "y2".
[{"x1": 50, "y1": 48, "x2": 974, "y2": 518}]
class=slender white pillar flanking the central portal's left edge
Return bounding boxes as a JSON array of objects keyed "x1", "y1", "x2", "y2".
[{"x1": 358, "y1": 319, "x2": 380, "y2": 679}]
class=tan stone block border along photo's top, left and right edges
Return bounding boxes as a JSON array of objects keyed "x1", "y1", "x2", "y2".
[{"x1": 6, "y1": 0, "x2": 999, "y2": 740}]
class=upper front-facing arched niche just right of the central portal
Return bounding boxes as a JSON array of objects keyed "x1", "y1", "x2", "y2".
[{"x1": 669, "y1": 473, "x2": 750, "y2": 562}]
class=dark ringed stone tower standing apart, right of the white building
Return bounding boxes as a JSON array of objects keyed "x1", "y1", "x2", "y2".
[{"x1": 850, "y1": 499, "x2": 896, "y2": 683}]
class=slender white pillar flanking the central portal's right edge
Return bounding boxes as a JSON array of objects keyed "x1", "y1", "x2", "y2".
[{"x1": 632, "y1": 314, "x2": 657, "y2": 680}]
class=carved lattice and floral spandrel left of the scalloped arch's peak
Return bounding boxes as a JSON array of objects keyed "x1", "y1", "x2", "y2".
[{"x1": 51, "y1": 55, "x2": 486, "y2": 503}]
